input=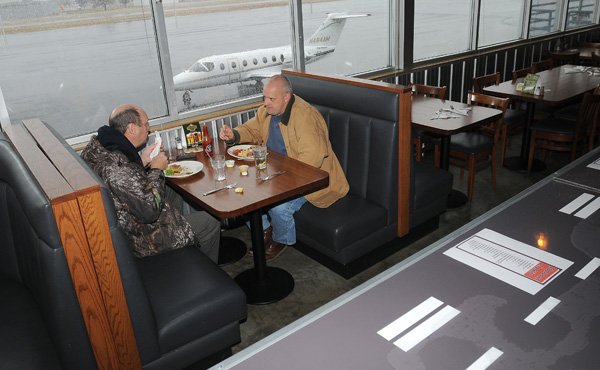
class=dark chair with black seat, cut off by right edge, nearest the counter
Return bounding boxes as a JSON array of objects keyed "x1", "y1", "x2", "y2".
[{"x1": 527, "y1": 93, "x2": 600, "y2": 172}]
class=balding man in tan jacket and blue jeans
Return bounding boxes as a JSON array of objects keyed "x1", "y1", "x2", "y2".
[{"x1": 219, "y1": 75, "x2": 349, "y2": 260}]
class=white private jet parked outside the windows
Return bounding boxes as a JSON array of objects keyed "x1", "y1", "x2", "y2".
[{"x1": 173, "y1": 13, "x2": 370, "y2": 105}]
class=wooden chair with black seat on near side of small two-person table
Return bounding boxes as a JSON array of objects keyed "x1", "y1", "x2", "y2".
[{"x1": 442, "y1": 92, "x2": 510, "y2": 201}]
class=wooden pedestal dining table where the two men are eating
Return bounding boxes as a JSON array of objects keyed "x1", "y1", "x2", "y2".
[{"x1": 167, "y1": 150, "x2": 329, "y2": 304}]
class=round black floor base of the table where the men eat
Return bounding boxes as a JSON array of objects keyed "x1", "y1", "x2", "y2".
[{"x1": 235, "y1": 266, "x2": 294, "y2": 304}]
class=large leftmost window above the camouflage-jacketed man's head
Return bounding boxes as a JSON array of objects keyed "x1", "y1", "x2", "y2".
[{"x1": 0, "y1": 1, "x2": 164, "y2": 138}]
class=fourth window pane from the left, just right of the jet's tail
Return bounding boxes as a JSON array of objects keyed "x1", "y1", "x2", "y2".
[{"x1": 413, "y1": 0, "x2": 473, "y2": 60}]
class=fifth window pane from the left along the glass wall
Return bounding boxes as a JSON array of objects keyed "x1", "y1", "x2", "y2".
[{"x1": 478, "y1": 0, "x2": 525, "y2": 47}]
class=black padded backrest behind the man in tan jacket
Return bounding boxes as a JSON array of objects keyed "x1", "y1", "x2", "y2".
[{"x1": 286, "y1": 75, "x2": 399, "y2": 223}]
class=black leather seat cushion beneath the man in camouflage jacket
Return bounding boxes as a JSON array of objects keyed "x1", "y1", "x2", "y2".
[{"x1": 137, "y1": 248, "x2": 246, "y2": 353}]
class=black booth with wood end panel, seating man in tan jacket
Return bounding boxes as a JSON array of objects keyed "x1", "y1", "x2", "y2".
[{"x1": 284, "y1": 71, "x2": 452, "y2": 277}]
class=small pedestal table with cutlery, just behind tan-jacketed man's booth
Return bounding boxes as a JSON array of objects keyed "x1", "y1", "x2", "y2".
[{"x1": 412, "y1": 95, "x2": 502, "y2": 208}]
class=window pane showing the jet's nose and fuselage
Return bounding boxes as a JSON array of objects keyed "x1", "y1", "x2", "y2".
[{"x1": 165, "y1": 0, "x2": 290, "y2": 113}]
